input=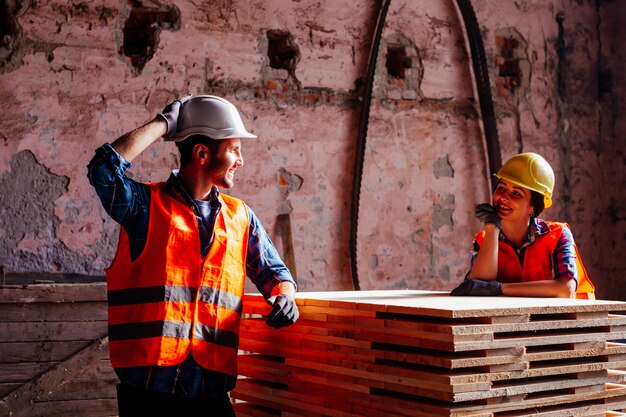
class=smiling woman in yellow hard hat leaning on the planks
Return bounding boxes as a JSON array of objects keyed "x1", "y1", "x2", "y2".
[{"x1": 450, "y1": 152, "x2": 595, "y2": 299}]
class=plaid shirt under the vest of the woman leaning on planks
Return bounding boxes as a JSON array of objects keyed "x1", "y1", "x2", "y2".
[{"x1": 466, "y1": 218, "x2": 578, "y2": 283}]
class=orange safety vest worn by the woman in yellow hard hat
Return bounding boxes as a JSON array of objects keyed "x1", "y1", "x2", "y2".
[{"x1": 475, "y1": 221, "x2": 595, "y2": 299}]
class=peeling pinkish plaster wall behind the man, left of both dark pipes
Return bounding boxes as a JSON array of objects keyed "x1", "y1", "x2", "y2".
[{"x1": 0, "y1": 1, "x2": 375, "y2": 289}]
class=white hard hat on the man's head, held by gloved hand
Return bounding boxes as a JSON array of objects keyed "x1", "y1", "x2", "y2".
[{"x1": 169, "y1": 95, "x2": 256, "y2": 142}]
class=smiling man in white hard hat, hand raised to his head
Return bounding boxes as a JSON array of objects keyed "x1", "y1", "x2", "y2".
[{"x1": 88, "y1": 92, "x2": 299, "y2": 417}]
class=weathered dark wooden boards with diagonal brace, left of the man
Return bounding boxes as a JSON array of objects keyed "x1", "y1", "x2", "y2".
[{"x1": 0, "y1": 283, "x2": 117, "y2": 417}]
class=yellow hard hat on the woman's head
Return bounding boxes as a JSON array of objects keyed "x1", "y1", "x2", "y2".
[{"x1": 494, "y1": 152, "x2": 554, "y2": 208}]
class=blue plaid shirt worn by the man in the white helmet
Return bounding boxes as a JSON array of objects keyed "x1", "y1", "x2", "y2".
[{"x1": 87, "y1": 144, "x2": 296, "y2": 397}]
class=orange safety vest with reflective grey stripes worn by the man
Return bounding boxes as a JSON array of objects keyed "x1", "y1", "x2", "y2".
[{"x1": 105, "y1": 183, "x2": 250, "y2": 375}]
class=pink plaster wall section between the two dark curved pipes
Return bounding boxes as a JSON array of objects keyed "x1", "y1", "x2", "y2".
[{"x1": 357, "y1": 1, "x2": 480, "y2": 289}]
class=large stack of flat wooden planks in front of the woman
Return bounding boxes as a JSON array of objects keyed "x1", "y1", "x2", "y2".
[{"x1": 232, "y1": 291, "x2": 626, "y2": 417}]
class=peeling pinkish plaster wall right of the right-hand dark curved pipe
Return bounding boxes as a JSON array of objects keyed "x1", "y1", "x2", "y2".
[{"x1": 476, "y1": 1, "x2": 626, "y2": 299}]
